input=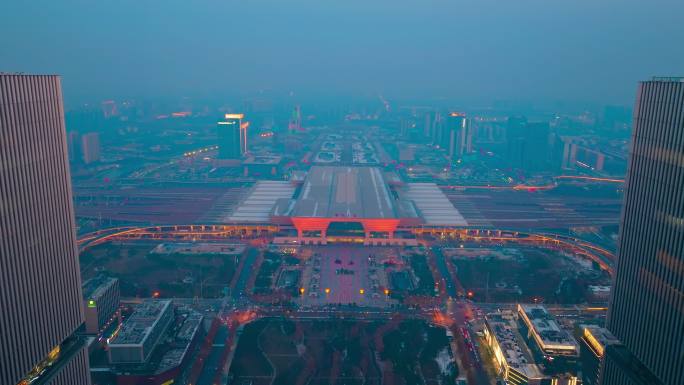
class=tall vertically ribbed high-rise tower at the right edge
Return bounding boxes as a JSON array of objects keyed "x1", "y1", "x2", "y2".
[{"x1": 603, "y1": 78, "x2": 684, "y2": 385}]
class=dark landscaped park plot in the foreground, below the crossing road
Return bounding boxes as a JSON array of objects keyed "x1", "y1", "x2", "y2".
[{"x1": 229, "y1": 319, "x2": 456, "y2": 385}]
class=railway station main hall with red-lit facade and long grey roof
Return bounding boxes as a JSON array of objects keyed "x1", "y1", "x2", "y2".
[{"x1": 272, "y1": 167, "x2": 422, "y2": 245}]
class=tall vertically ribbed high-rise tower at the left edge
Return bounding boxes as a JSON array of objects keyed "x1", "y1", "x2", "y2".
[{"x1": 0, "y1": 74, "x2": 90, "y2": 385}]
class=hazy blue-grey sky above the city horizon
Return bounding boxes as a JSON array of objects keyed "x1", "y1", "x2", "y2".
[{"x1": 0, "y1": 0, "x2": 684, "y2": 104}]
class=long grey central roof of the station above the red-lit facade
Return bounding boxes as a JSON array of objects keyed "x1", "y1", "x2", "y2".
[{"x1": 290, "y1": 166, "x2": 401, "y2": 218}]
